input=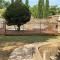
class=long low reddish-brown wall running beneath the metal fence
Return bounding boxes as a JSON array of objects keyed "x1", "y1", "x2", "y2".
[{"x1": 0, "y1": 28, "x2": 57, "y2": 35}]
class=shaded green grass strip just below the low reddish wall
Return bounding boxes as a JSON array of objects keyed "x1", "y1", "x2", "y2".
[{"x1": 0, "y1": 35, "x2": 56, "y2": 43}]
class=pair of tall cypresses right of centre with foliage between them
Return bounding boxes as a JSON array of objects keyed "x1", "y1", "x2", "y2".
[{"x1": 38, "y1": 0, "x2": 49, "y2": 18}]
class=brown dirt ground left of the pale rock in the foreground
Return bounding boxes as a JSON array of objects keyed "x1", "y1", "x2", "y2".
[{"x1": 0, "y1": 42, "x2": 25, "y2": 60}]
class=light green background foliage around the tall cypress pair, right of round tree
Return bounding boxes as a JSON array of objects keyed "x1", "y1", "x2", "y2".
[{"x1": 30, "y1": 5, "x2": 60, "y2": 18}]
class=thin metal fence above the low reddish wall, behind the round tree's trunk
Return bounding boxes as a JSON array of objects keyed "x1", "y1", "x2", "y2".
[{"x1": 6, "y1": 23, "x2": 57, "y2": 30}]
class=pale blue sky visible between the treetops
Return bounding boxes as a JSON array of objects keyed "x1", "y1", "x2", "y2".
[{"x1": 6, "y1": 0, "x2": 60, "y2": 7}]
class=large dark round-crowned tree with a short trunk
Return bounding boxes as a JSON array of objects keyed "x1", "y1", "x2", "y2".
[{"x1": 3, "y1": 2, "x2": 31, "y2": 31}]
